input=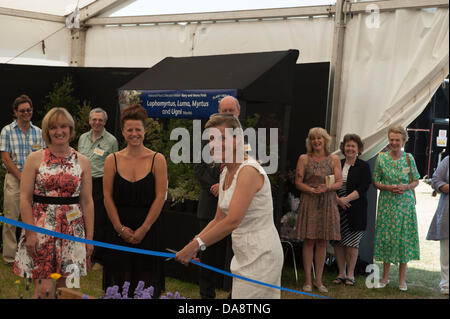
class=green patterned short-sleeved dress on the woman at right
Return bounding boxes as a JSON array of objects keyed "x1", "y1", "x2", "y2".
[{"x1": 373, "y1": 152, "x2": 420, "y2": 263}]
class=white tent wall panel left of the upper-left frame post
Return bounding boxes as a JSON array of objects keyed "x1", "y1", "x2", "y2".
[{"x1": 0, "y1": 15, "x2": 71, "y2": 66}]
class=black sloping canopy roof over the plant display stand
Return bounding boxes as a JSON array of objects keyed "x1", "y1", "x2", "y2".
[{"x1": 120, "y1": 50, "x2": 299, "y2": 103}]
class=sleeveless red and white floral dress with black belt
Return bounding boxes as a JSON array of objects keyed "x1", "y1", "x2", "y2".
[{"x1": 13, "y1": 148, "x2": 88, "y2": 279}]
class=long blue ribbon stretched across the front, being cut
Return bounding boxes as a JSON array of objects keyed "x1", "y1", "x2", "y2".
[{"x1": 0, "y1": 216, "x2": 329, "y2": 299}]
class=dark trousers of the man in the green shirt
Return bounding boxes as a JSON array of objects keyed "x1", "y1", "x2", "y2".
[{"x1": 92, "y1": 177, "x2": 108, "y2": 264}]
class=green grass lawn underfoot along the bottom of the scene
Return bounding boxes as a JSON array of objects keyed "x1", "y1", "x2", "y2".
[{"x1": 0, "y1": 264, "x2": 448, "y2": 299}]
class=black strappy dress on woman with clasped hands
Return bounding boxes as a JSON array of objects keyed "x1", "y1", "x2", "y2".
[{"x1": 103, "y1": 153, "x2": 165, "y2": 298}]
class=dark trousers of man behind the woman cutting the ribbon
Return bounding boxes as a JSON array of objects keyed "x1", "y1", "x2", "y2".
[{"x1": 199, "y1": 219, "x2": 232, "y2": 299}]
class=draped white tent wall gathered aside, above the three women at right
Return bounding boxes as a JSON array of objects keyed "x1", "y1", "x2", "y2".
[{"x1": 336, "y1": 8, "x2": 449, "y2": 159}]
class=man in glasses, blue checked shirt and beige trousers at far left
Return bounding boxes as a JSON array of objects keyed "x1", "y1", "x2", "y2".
[{"x1": 0, "y1": 94, "x2": 45, "y2": 265}]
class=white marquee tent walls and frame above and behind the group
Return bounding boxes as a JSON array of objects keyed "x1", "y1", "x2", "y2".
[{"x1": 0, "y1": 0, "x2": 449, "y2": 159}]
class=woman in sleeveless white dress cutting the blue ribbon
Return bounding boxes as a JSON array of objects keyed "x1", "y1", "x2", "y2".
[{"x1": 175, "y1": 113, "x2": 283, "y2": 299}]
